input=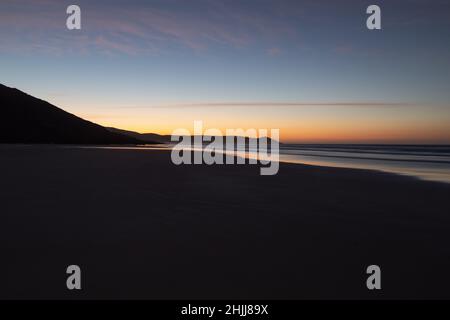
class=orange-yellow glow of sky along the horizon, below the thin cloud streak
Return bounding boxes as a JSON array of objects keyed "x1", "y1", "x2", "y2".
[{"x1": 75, "y1": 102, "x2": 450, "y2": 144}]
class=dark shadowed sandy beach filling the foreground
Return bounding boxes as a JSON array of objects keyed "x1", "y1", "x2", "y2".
[{"x1": 0, "y1": 146, "x2": 450, "y2": 299}]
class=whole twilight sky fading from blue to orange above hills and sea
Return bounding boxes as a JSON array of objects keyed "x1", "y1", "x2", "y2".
[{"x1": 0, "y1": 0, "x2": 450, "y2": 143}]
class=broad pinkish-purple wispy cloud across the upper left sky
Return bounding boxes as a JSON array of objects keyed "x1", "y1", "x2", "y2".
[{"x1": 0, "y1": 0, "x2": 302, "y2": 55}]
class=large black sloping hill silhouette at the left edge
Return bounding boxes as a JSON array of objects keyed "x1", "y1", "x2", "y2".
[{"x1": 0, "y1": 84, "x2": 143, "y2": 144}]
